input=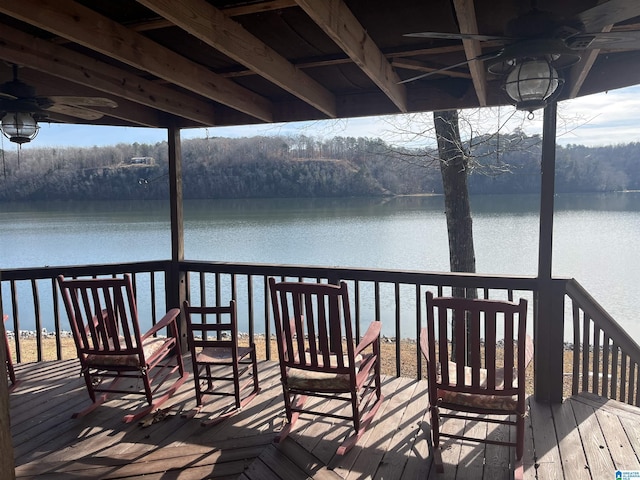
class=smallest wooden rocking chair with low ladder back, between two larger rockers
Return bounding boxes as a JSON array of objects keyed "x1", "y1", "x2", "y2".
[{"x1": 184, "y1": 300, "x2": 260, "y2": 426}]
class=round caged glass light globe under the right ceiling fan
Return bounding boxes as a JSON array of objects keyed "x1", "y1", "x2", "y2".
[{"x1": 504, "y1": 60, "x2": 560, "y2": 111}]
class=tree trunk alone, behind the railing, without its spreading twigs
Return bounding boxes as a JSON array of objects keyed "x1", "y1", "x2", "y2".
[{"x1": 433, "y1": 110, "x2": 476, "y2": 284}]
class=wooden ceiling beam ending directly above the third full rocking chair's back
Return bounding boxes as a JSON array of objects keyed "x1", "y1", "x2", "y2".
[{"x1": 137, "y1": 0, "x2": 337, "y2": 118}]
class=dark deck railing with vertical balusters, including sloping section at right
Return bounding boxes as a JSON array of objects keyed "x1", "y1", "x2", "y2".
[{"x1": 0, "y1": 261, "x2": 640, "y2": 405}]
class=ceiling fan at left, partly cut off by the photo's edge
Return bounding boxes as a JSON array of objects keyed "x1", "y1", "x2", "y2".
[{"x1": 0, "y1": 65, "x2": 118, "y2": 144}]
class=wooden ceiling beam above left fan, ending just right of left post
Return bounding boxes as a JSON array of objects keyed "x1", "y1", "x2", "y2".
[{"x1": 0, "y1": 25, "x2": 215, "y2": 127}]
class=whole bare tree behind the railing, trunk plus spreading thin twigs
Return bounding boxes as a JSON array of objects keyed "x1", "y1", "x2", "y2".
[{"x1": 380, "y1": 109, "x2": 531, "y2": 297}]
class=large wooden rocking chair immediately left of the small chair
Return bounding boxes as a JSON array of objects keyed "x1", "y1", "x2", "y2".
[{"x1": 58, "y1": 275, "x2": 189, "y2": 422}]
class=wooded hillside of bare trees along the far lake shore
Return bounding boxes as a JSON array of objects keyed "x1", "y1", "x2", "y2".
[{"x1": 0, "y1": 133, "x2": 640, "y2": 201}]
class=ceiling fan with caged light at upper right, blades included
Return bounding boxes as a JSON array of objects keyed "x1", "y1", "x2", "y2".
[{"x1": 399, "y1": 0, "x2": 640, "y2": 111}]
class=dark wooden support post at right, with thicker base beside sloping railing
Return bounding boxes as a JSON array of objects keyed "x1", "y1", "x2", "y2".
[{"x1": 534, "y1": 102, "x2": 564, "y2": 403}]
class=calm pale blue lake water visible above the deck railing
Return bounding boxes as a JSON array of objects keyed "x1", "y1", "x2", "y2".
[{"x1": 0, "y1": 192, "x2": 640, "y2": 338}]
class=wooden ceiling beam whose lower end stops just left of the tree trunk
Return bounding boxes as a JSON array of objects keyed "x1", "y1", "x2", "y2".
[{"x1": 296, "y1": 0, "x2": 407, "y2": 113}]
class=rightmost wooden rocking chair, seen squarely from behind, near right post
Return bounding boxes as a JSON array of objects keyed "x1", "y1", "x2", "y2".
[{"x1": 420, "y1": 292, "x2": 533, "y2": 473}]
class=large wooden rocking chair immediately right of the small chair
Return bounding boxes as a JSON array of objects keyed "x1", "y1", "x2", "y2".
[{"x1": 269, "y1": 278, "x2": 384, "y2": 455}]
